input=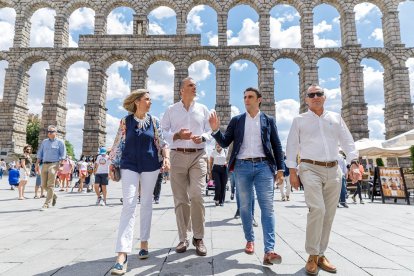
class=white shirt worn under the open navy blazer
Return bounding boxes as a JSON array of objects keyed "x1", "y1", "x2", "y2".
[{"x1": 237, "y1": 111, "x2": 266, "y2": 159}]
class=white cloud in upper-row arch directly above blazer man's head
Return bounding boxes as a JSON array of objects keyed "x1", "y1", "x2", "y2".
[{"x1": 227, "y1": 18, "x2": 260, "y2": 46}]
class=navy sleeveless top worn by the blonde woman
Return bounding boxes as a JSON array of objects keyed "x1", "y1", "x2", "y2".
[{"x1": 121, "y1": 114, "x2": 161, "y2": 173}]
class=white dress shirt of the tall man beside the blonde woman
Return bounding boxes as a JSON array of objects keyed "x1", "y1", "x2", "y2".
[{"x1": 161, "y1": 101, "x2": 211, "y2": 149}]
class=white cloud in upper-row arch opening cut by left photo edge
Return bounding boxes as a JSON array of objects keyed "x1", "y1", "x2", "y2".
[{"x1": 0, "y1": 8, "x2": 16, "y2": 51}]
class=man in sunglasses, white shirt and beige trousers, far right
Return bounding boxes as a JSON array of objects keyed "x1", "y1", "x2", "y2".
[{"x1": 286, "y1": 84, "x2": 358, "y2": 275}]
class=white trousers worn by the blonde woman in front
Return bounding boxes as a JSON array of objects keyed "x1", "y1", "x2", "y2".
[{"x1": 116, "y1": 167, "x2": 159, "y2": 253}]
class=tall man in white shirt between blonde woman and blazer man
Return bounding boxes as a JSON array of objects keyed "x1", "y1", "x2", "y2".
[{"x1": 161, "y1": 77, "x2": 210, "y2": 256}]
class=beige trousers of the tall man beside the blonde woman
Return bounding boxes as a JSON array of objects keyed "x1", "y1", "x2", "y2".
[{"x1": 170, "y1": 150, "x2": 207, "y2": 242}]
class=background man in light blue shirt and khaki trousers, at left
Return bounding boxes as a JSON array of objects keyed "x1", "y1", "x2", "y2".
[{"x1": 36, "y1": 125, "x2": 66, "y2": 211}]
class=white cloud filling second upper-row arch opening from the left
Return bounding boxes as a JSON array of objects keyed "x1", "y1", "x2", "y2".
[{"x1": 30, "y1": 8, "x2": 56, "y2": 47}]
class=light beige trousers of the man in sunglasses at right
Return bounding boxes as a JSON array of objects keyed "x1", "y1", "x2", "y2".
[{"x1": 299, "y1": 163, "x2": 342, "y2": 255}]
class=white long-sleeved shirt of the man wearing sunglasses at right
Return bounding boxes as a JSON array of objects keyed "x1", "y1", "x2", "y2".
[{"x1": 286, "y1": 110, "x2": 358, "y2": 168}]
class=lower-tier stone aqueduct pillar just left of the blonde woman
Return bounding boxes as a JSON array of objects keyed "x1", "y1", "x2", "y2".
[{"x1": 82, "y1": 68, "x2": 108, "y2": 155}]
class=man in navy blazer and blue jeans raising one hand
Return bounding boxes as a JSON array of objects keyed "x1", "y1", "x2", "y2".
[{"x1": 209, "y1": 87, "x2": 284, "y2": 265}]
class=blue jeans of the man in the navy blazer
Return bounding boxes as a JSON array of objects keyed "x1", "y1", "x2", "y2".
[{"x1": 234, "y1": 159, "x2": 275, "y2": 253}]
